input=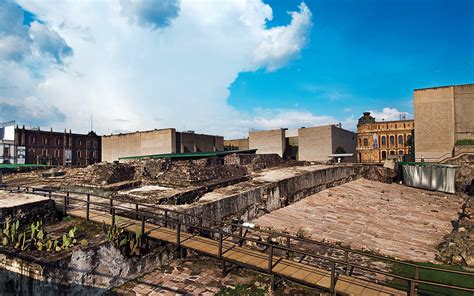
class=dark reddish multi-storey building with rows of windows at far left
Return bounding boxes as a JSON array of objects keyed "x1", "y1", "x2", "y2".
[{"x1": 3, "y1": 126, "x2": 101, "y2": 165}]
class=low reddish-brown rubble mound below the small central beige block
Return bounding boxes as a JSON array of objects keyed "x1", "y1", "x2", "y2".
[{"x1": 224, "y1": 154, "x2": 284, "y2": 172}]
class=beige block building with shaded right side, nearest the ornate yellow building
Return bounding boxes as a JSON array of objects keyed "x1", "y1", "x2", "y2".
[{"x1": 298, "y1": 125, "x2": 357, "y2": 161}]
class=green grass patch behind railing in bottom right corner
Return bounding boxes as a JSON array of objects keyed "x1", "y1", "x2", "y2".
[{"x1": 388, "y1": 263, "x2": 474, "y2": 296}]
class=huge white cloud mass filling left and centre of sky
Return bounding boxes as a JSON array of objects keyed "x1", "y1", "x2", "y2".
[{"x1": 4, "y1": 0, "x2": 314, "y2": 136}]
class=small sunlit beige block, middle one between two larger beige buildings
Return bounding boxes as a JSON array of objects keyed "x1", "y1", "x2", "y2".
[{"x1": 249, "y1": 129, "x2": 286, "y2": 157}]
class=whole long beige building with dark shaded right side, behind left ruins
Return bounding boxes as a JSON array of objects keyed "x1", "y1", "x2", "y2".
[{"x1": 102, "y1": 128, "x2": 224, "y2": 161}]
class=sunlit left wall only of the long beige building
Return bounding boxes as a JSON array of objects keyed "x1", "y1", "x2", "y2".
[{"x1": 102, "y1": 128, "x2": 176, "y2": 161}]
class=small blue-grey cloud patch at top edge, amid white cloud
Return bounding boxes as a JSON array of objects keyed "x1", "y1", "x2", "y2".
[{"x1": 120, "y1": 0, "x2": 179, "y2": 29}]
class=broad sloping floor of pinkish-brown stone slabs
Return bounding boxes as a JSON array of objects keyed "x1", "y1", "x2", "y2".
[{"x1": 253, "y1": 179, "x2": 463, "y2": 262}]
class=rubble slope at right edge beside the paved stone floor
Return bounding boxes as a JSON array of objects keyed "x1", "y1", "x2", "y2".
[{"x1": 437, "y1": 199, "x2": 474, "y2": 269}]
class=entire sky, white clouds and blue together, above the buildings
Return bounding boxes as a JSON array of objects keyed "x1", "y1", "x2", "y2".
[{"x1": 0, "y1": 0, "x2": 474, "y2": 138}]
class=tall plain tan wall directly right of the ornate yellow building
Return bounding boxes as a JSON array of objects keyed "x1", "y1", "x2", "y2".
[{"x1": 414, "y1": 87, "x2": 455, "y2": 160}]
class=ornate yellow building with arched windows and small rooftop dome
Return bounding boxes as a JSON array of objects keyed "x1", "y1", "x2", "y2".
[{"x1": 357, "y1": 112, "x2": 414, "y2": 163}]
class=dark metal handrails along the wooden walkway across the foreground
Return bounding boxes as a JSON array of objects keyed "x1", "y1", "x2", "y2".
[{"x1": 3, "y1": 186, "x2": 474, "y2": 292}]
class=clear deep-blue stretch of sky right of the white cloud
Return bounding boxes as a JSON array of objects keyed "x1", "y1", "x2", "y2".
[{"x1": 229, "y1": 0, "x2": 474, "y2": 120}]
